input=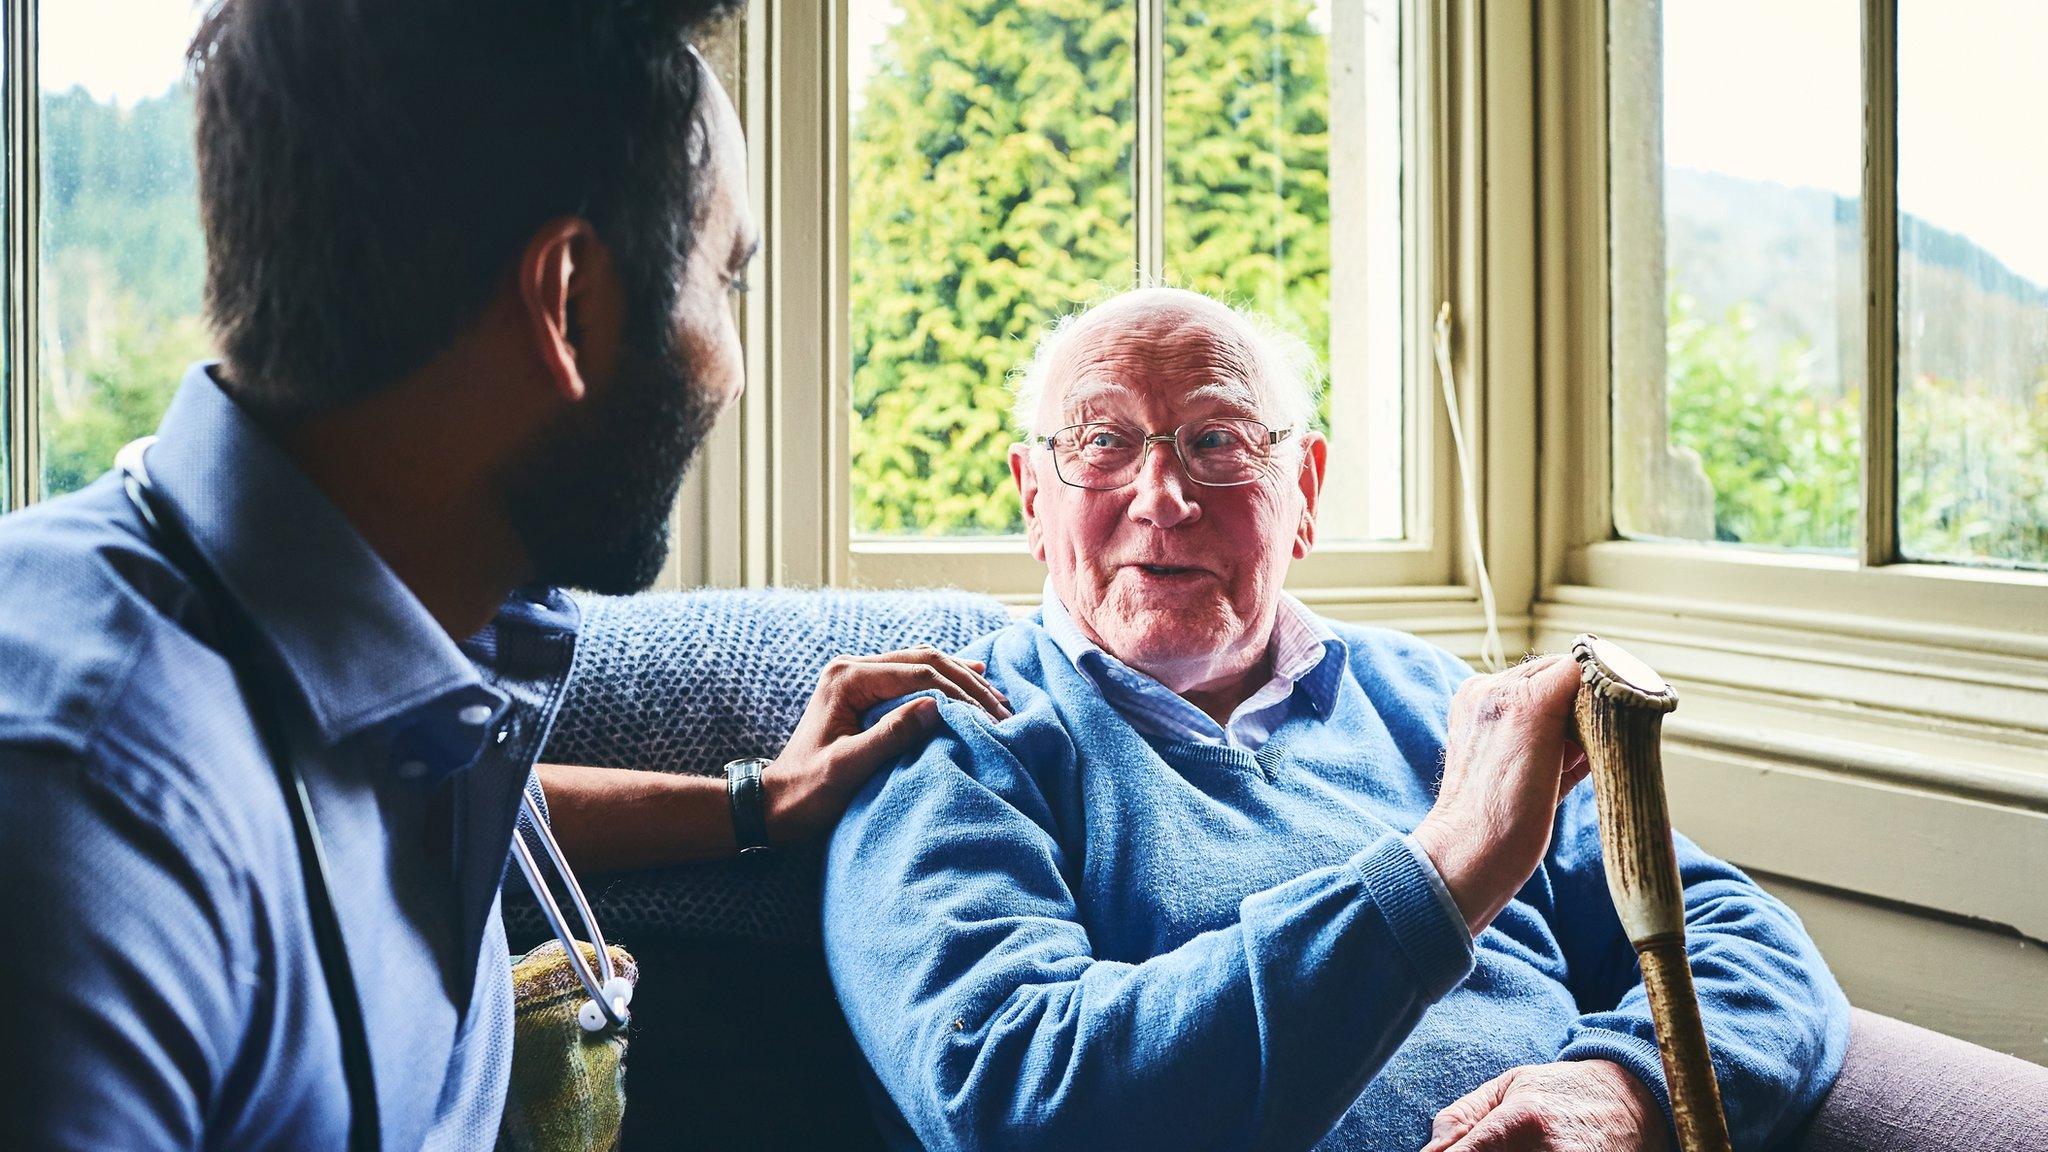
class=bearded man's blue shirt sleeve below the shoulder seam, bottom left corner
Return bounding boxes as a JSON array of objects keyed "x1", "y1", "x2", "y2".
[{"x1": 0, "y1": 746, "x2": 254, "y2": 1152}]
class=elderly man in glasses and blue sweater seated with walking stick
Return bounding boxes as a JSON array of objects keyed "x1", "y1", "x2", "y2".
[{"x1": 825, "y1": 289, "x2": 1847, "y2": 1152}]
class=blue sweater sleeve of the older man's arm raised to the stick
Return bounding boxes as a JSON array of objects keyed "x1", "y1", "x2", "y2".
[{"x1": 825, "y1": 705, "x2": 1473, "y2": 1148}]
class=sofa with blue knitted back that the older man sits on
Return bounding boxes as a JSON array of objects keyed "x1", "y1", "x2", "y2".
[{"x1": 506, "y1": 590, "x2": 2048, "y2": 1152}]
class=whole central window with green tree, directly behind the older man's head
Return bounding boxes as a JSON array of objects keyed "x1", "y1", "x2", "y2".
[{"x1": 846, "y1": 0, "x2": 1413, "y2": 541}]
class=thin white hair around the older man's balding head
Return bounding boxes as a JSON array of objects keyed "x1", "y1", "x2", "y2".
[{"x1": 1010, "y1": 285, "x2": 1323, "y2": 437}]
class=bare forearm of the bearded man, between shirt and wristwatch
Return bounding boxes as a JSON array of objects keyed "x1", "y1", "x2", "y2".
[{"x1": 535, "y1": 765, "x2": 739, "y2": 873}]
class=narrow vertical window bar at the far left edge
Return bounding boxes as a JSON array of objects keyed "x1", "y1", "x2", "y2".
[{"x1": 0, "y1": 0, "x2": 43, "y2": 510}]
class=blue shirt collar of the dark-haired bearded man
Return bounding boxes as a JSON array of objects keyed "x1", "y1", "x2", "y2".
[{"x1": 147, "y1": 365, "x2": 506, "y2": 777}]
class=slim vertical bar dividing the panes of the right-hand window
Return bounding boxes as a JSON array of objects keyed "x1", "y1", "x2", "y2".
[{"x1": 1860, "y1": 0, "x2": 1898, "y2": 568}]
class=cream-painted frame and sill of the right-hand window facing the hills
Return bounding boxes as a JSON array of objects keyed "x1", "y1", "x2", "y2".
[{"x1": 1534, "y1": 0, "x2": 2048, "y2": 736}]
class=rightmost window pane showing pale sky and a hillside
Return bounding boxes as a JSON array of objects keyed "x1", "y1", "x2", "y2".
[{"x1": 1898, "y1": 0, "x2": 2048, "y2": 566}]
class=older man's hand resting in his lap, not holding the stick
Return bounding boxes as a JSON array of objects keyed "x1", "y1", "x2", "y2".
[{"x1": 1421, "y1": 1060, "x2": 1671, "y2": 1152}]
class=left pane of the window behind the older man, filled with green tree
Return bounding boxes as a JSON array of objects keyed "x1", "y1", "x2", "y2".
[{"x1": 846, "y1": 0, "x2": 1137, "y2": 535}]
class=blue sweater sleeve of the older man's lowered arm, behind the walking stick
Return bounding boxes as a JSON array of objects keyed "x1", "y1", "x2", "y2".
[{"x1": 1548, "y1": 783, "x2": 1849, "y2": 1148}]
